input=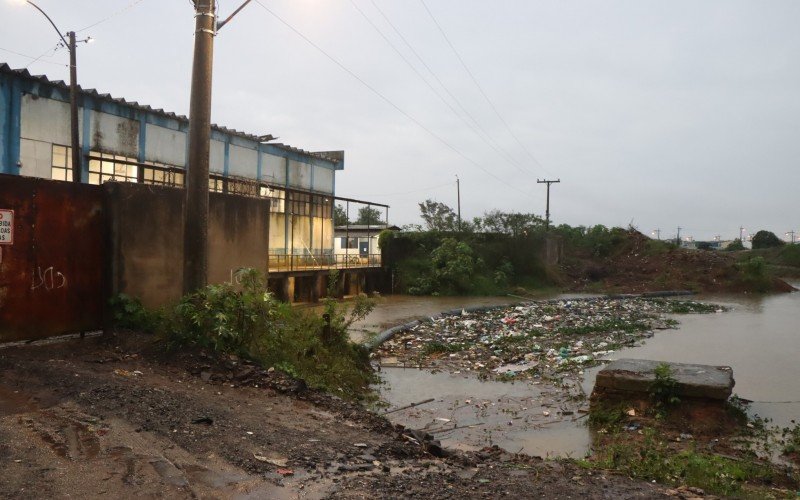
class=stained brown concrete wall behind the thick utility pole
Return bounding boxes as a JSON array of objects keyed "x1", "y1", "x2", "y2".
[{"x1": 104, "y1": 183, "x2": 270, "y2": 307}]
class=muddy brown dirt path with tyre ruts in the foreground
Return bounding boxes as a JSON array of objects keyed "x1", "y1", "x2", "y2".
[{"x1": 0, "y1": 335, "x2": 676, "y2": 498}]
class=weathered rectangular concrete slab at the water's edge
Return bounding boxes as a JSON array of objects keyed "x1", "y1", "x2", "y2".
[{"x1": 595, "y1": 359, "x2": 736, "y2": 400}]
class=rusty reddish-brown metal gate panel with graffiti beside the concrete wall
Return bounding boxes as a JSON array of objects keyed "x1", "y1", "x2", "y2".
[{"x1": 0, "y1": 175, "x2": 107, "y2": 342}]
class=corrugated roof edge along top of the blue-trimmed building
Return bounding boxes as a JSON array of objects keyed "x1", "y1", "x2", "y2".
[{"x1": 0, "y1": 63, "x2": 342, "y2": 163}]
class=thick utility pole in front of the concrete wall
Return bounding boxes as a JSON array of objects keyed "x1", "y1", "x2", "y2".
[{"x1": 183, "y1": 0, "x2": 217, "y2": 293}]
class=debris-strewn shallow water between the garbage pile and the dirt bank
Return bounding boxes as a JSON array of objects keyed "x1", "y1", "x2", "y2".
[{"x1": 381, "y1": 367, "x2": 591, "y2": 458}]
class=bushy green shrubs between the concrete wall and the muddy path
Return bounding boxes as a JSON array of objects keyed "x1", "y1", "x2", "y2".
[{"x1": 111, "y1": 269, "x2": 374, "y2": 399}]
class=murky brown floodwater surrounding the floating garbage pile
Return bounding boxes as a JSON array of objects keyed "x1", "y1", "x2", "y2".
[{"x1": 374, "y1": 290, "x2": 800, "y2": 458}]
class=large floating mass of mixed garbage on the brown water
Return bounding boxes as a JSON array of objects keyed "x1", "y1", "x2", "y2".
[{"x1": 376, "y1": 299, "x2": 724, "y2": 380}]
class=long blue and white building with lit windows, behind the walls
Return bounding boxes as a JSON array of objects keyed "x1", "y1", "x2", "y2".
[{"x1": 0, "y1": 63, "x2": 344, "y2": 262}]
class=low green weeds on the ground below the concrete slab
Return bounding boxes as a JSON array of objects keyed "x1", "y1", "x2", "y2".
[{"x1": 579, "y1": 428, "x2": 774, "y2": 496}]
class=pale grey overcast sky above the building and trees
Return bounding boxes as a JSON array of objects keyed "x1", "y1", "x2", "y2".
[{"x1": 0, "y1": 0, "x2": 800, "y2": 240}]
